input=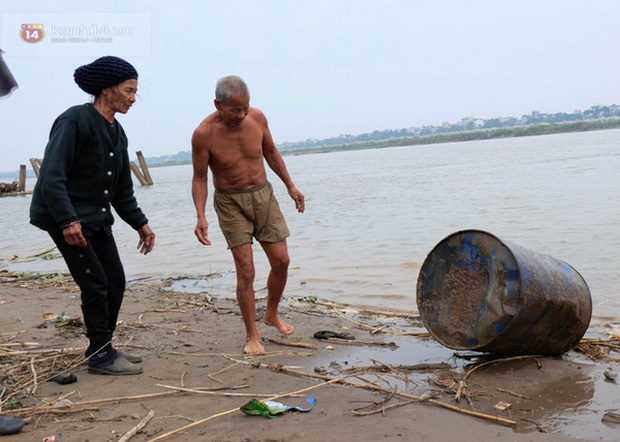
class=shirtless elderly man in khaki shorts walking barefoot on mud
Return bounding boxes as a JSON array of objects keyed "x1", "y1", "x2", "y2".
[{"x1": 192, "y1": 76, "x2": 305, "y2": 354}]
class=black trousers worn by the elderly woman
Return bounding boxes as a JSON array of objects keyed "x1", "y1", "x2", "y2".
[{"x1": 48, "y1": 229, "x2": 125, "y2": 356}]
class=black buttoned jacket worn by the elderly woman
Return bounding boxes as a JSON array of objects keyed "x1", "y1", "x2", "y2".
[{"x1": 30, "y1": 103, "x2": 148, "y2": 234}]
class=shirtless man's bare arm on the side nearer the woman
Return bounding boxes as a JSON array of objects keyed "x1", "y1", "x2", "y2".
[{"x1": 192, "y1": 125, "x2": 211, "y2": 246}]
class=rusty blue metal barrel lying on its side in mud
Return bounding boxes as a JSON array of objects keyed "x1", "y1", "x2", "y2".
[{"x1": 417, "y1": 230, "x2": 592, "y2": 355}]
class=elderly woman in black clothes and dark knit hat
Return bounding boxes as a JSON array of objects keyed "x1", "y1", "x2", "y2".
[{"x1": 30, "y1": 56, "x2": 155, "y2": 375}]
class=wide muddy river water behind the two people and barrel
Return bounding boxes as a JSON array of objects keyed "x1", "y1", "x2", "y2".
[{"x1": 0, "y1": 130, "x2": 620, "y2": 318}]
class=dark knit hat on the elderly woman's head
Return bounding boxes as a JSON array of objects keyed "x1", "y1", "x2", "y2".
[{"x1": 73, "y1": 55, "x2": 138, "y2": 95}]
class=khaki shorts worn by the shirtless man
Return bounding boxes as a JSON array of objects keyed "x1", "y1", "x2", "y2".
[{"x1": 213, "y1": 182, "x2": 290, "y2": 249}]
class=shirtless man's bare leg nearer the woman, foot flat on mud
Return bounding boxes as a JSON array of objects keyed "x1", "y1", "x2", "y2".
[{"x1": 231, "y1": 244, "x2": 265, "y2": 355}]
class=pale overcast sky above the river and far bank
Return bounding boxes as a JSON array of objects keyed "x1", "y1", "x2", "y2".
[{"x1": 0, "y1": 0, "x2": 620, "y2": 171}]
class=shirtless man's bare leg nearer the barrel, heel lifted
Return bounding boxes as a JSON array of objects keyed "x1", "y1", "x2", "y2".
[{"x1": 260, "y1": 240, "x2": 295, "y2": 336}]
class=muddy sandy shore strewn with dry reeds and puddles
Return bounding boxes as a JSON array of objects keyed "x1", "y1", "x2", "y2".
[{"x1": 0, "y1": 273, "x2": 620, "y2": 442}]
